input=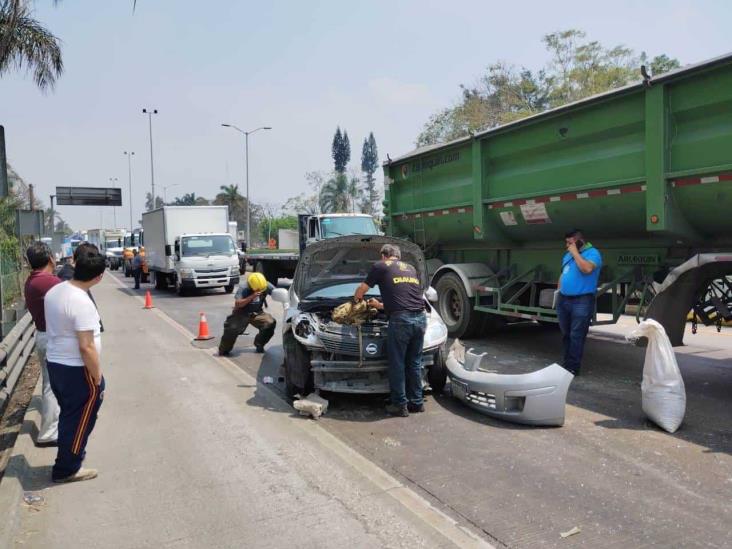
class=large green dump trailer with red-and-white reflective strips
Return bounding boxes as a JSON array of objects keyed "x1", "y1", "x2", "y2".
[{"x1": 384, "y1": 51, "x2": 732, "y2": 345}]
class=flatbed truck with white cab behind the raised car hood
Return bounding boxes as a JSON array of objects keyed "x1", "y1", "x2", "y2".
[{"x1": 244, "y1": 213, "x2": 379, "y2": 286}]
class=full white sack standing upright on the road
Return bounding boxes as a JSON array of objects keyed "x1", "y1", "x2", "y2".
[{"x1": 626, "y1": 319, "x2": 686, "y2": 433}]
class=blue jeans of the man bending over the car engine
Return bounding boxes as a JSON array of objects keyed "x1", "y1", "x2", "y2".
[{"x1": 386, "y1": 311, "x2": 427, "y2": 406}]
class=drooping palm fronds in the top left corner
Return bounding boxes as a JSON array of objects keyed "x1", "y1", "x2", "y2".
[{"x1": 0, "y1": 0, "x2": 64, "y2": 91}]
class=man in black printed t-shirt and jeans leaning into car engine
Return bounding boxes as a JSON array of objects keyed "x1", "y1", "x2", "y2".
[{"x1": 354, "y1": 244, "x2": 427, "y2": 417}]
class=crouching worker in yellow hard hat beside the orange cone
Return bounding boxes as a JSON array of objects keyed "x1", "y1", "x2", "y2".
[{"x1": 219, "y1": 273, "x2": 277, "y2": 356}]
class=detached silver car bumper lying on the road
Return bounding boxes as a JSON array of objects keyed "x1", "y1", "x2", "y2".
[{"x1": 447, "y1": 340, "x2": 574, "y2": 426}]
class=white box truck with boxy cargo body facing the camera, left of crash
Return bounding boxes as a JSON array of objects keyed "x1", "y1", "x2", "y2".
[{"x1": 142, "y1": 206, "x2": 239, "y2": 295}]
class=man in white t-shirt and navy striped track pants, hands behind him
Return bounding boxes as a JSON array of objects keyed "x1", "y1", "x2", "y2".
[{"x1": 44, "y1": 248, "x2": 105, "y2": 482}]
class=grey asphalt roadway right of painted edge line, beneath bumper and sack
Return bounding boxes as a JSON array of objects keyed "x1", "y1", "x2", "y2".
[{"x1": 115, "y1": 274, "x2": 732, "y2": 547}]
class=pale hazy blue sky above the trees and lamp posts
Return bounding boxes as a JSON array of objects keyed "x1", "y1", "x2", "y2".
[{"x1": 0, "y1": 0, "x2": 732, "y2": 229}]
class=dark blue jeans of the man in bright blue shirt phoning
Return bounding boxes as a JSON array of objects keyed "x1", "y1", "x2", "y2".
[{"x1": 557, "y1": 294, "x2": 595, "y2": 375}]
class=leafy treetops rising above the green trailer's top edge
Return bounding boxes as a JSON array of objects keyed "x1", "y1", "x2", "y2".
[{"x1": 417, "y1": 29, "x2": 680, "y2": 147}]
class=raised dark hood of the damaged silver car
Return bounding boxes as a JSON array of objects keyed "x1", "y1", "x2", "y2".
[{"x1": 292, "y1": 235, "x2": 428, "y2": 299}]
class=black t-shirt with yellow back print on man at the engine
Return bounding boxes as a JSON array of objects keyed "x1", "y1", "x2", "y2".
[{"x1": 365, "y1": 260, "x2": 424, "y2": 314}]
